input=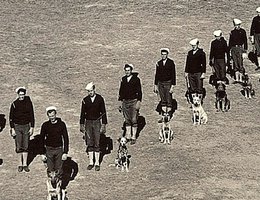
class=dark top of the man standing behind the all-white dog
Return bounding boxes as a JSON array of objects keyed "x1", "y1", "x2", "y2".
[{"x1": 185, "y1": 49, "x2": 206, "y2": 73}]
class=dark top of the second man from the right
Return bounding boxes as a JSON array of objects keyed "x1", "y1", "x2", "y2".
[{"x1": 228, "y1": 28, "x2": 248, "y2": 50}]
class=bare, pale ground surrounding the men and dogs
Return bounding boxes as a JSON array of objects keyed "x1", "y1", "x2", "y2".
[{"x1": 0, "y1": 0, "x2": 260, "y2": 200}]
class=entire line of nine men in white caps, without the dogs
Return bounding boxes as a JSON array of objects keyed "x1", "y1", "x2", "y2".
[{"x1": 5, "y1": 7, "x2": 260, "y2": 177}]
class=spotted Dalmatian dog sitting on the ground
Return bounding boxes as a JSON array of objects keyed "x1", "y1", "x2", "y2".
[{"x1": 115, "y1": 137, "x2": 131, "y2": 172}]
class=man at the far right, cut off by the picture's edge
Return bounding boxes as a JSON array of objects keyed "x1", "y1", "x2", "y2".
[{"x1": 250, "y1": 7, "x2": 260, "y2": 70}]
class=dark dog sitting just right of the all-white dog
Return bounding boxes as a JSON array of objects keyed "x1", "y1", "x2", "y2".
[{"x1": 215, "y1": 81, "x2": 230, "y2": 112}]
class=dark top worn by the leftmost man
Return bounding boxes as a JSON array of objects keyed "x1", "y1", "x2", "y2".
[{"x1": 9, "y1": 96, "x2": 35, "y2": 128}]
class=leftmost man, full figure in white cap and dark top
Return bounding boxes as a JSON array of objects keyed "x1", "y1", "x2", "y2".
[{"x1": 9, "y1": 87, "x2": 35, "y2": 172}]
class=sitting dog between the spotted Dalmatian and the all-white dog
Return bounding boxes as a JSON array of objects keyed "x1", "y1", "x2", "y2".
[{"x1": 159, "y1": 112, "x2": 173, "y2": 144}]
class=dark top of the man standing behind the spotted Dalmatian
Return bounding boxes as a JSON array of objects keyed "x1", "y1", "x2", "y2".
[{"x1": 118, "y1": 72, "x2": 142, "y2": 101}]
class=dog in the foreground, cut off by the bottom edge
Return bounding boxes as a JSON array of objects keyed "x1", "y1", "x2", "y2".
[{"x1": 47, "y1": 170, "x2": 64, "y2": 200}]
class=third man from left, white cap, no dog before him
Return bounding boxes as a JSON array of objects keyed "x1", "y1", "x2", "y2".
[{"x1": 80, "y1": 82, "x2": 107, "y2": 171}]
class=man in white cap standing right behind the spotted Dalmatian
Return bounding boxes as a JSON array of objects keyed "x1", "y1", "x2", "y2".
[{"x1": 118, "y1": 64, "x2": 142, "y2": 144}]
